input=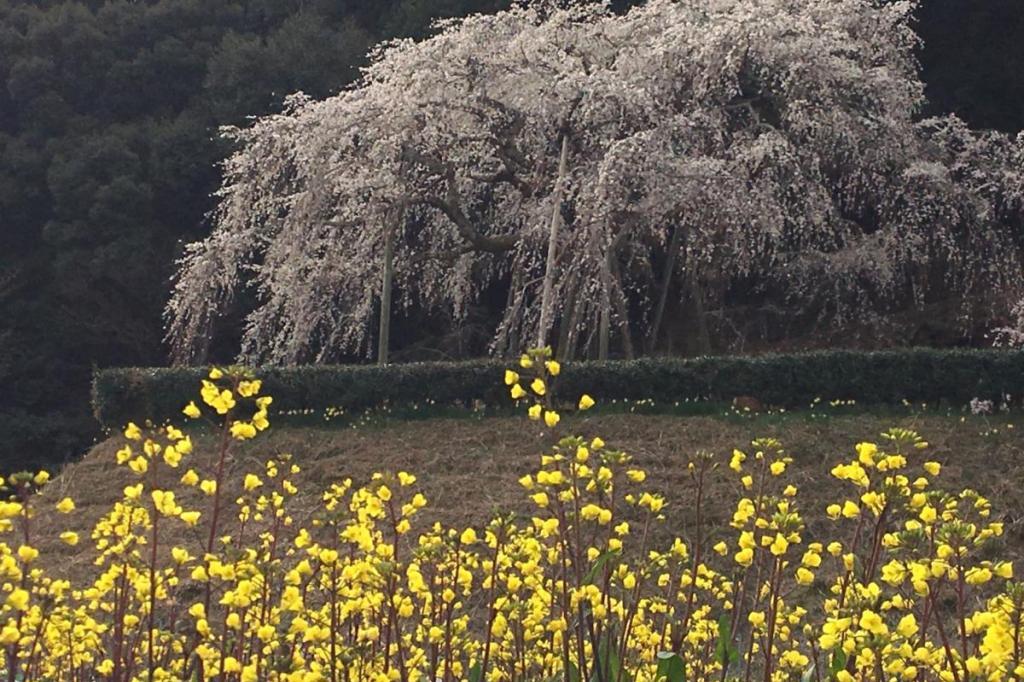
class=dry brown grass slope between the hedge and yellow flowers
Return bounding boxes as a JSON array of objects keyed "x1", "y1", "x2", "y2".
[{"x1": 28, "y1": 415, "x2": 1024, "y2": 577}]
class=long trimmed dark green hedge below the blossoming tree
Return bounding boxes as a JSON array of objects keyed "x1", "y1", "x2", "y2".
[{"x1": 92, "y1": 348, "x2": 1024, "y2": 427}]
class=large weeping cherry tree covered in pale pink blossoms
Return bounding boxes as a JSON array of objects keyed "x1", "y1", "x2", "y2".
[{"x1": 167, "y1": 0, "x2": 1024, "y2": 364}]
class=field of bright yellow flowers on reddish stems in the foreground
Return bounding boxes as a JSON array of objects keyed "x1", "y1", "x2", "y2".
[{"x1": 0, "y1": 350, "x2": 1024, "y2": 682}]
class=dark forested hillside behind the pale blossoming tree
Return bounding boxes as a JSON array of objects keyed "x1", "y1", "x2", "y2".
[{"x1": 0, "y1": 0, "x2": 1024, "y2": 469}]
